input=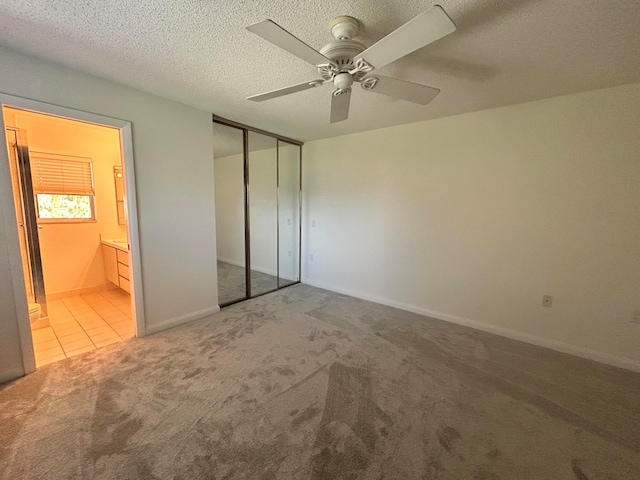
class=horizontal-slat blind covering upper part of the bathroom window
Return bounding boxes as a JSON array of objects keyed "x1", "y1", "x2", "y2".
[{"x1": 30, "y1": 153, "x2": 94, "y2": 195}]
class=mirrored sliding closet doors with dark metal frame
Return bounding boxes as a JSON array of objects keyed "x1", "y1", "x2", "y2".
[{"x1": 214, "y1": 116, "x2": 302, "y2": 306}]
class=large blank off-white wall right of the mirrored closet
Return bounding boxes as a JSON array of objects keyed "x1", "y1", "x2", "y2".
[{"x1": 303, "y1": 85, "x2": 640, "y2": 369}]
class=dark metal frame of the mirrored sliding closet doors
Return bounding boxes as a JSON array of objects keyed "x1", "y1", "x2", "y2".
[{"x1": 213, "y1": 115, "x2": 304, "y2": 307}]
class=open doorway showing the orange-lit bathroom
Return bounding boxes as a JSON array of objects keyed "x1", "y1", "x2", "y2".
[{"x1": 2, "y1": 100, "x2": 141, "y2": 367}]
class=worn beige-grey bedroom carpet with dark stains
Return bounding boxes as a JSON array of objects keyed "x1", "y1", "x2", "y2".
[{"x1": 0, "y1": 285, "x2": 640, "y2": 480}]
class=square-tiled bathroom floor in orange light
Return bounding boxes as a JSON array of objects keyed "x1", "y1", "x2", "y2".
[{"x1": 32, "y1": 289, "x2": 134, "y2": 367}]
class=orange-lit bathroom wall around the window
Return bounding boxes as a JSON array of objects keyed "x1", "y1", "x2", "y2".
[{"x1": 5, "y1": 111, "x2": 126, "y2": 295}]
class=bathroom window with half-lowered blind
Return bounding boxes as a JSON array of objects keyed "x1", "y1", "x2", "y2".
[{"x1": 31, "y1": 152, "x2": 95, "y2": 222}]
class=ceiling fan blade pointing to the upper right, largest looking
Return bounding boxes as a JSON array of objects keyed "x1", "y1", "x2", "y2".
[{"x1": 354, "y1": 5, "x2": 456, "y2": 68}]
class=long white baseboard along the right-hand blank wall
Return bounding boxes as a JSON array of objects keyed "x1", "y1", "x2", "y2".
[{"x1": 302, "y1": 278, "x2": 640, "y2": 372}]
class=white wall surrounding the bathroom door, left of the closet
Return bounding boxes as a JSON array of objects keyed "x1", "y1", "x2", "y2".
[{"x1": 0, "y1": 48, "x2": 218, "y2": 380}]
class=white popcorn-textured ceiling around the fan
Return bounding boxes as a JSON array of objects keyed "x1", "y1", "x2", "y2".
[{"x1": 0, "y1": 0, "x2": 640, "y2": 140}]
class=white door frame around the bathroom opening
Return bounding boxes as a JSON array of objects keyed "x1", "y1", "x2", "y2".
[{"x1": 0, "y1": 93, "x2": 145, "y2": 374}]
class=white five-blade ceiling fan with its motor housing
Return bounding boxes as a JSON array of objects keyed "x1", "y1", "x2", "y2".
[{"x1": 247, "y1": 5, "x2": 456, "y2": 123}]
